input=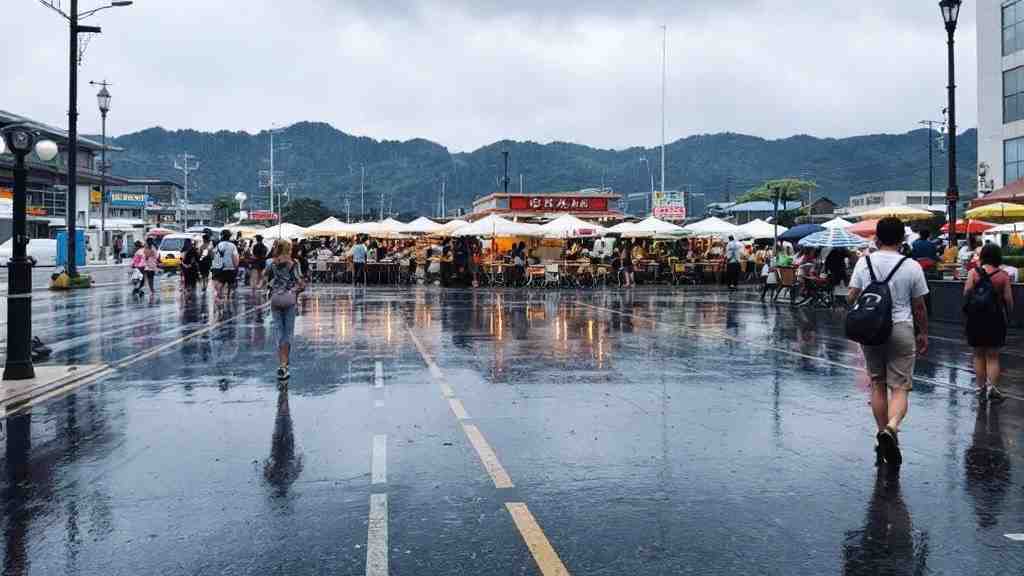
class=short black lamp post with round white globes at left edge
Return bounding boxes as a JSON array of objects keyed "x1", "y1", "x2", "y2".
[{"x1": 0, "y1": 124, "x2": 58, "y2": 380}]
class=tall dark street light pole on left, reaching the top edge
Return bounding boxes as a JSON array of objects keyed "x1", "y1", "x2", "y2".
[{"x1": 40, "y1": 0, "x2": 132, "y2": 277}]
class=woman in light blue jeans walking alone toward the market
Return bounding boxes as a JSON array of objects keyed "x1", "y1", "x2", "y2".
[{"x1": 266, "y1": 240, "x2": 305, "y2": 382}]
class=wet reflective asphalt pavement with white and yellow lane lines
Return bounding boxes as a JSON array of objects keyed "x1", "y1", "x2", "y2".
[{"x1": 0, "y1": 282, "x2": 1024, "y2": 576}]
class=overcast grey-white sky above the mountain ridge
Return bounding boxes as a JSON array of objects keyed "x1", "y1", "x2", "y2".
[{"x1": 0, "y1": 0, "x2": 977, "y2": 151}]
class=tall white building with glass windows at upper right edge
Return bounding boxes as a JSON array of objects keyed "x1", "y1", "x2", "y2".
[{"x1": 977, "y1": 0, "x2": 1024, "y2": 196}]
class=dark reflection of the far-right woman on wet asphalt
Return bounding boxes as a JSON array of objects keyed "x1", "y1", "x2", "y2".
[{"x1": 964, "y1": 407, "x2": 1011, "y2": 528}]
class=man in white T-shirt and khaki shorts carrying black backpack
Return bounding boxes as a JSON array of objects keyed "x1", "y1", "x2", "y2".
[{"x1": 846, "y1": 217, "x2": 928, "y2": 466}]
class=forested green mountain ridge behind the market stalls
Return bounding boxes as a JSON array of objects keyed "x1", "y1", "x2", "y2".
[{"x1": 101, "y1": 122, "x2": 977, "y2": 217}]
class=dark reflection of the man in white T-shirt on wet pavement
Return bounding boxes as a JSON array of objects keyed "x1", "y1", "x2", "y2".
[{"x1": 843, "y1": 468, "x2": 929, "y2": 576}]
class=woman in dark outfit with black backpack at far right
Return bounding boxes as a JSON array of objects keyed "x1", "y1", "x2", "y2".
[{"x1": 964, "y1": 244, "x2": 1014, "y2": 401}]
